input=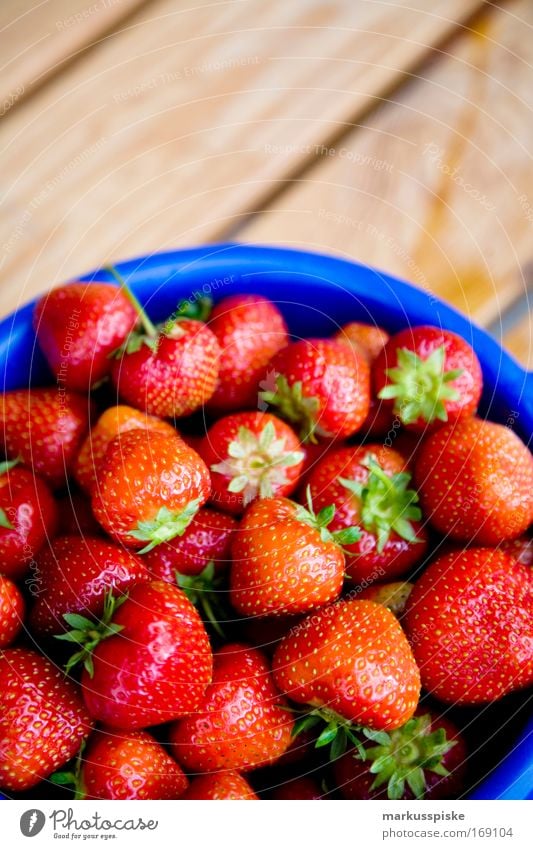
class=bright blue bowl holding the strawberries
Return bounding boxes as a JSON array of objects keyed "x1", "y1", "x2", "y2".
[{"x1": 0, "y1": 244, "x2": 533, "y2": 799}]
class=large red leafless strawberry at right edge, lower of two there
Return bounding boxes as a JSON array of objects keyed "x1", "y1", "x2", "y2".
[{"x1": 405, "y1": 548, "x2": 533, "y2": 705}]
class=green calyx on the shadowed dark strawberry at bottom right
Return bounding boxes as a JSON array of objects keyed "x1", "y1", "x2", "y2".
[{"x1": 354, "y1": 714, "x2": 457, "y2": 799}]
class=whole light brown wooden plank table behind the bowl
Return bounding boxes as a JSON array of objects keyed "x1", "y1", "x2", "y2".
[{"x1": 0, "y1": 0, "x2": 533, "y2": 368}]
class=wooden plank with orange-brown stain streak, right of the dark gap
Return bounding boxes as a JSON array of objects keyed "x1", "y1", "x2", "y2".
[{"x1": 238, "y1": 0, "x2": 533, "y2": 323}]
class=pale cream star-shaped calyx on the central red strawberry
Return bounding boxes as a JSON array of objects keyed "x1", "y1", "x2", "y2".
[{"x1": 211, "y1": 421, "x2": 305, "y2": 505}]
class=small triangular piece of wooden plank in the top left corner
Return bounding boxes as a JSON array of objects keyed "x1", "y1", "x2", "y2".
[{"x1": 0, "y1": 0, "x2": 146, "y2": 107}]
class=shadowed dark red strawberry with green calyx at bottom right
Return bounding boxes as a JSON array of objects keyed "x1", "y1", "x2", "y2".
[{"x1": 333, "y1": 711, "x2": 467, "y2": 799}]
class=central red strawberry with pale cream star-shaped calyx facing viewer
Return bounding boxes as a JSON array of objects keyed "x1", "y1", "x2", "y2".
[{"x1": 199, "y1": 412, "x2": 304, "y2": 513}]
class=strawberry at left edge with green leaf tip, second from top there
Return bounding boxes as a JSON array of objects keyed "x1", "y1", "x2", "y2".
[{"x1": 0, "y1": 460, "x2": 58, "y2": 580}]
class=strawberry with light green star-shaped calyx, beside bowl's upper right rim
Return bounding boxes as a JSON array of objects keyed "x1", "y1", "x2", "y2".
[{"x1": 373, "y1": 326, "x2": 483, "y2": 431}]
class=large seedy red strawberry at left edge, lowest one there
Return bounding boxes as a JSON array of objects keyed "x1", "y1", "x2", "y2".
[{"x1": 0, "y1": 649, "x2": 91, "y2": 792}]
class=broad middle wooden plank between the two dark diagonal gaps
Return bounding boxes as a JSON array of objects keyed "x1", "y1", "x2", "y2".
[{"x1": 0, "y1": 0, "x2": 481, "y2": 312}]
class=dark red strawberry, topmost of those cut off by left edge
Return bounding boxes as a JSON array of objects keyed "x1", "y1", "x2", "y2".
[{"x1": 0, "y1": 389, "x2": 92, "y2": 488}]
